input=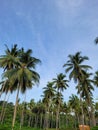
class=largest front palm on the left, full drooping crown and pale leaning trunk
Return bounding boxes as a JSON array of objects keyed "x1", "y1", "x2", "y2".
[{"x1": 9, "y1": 50, "x2": 39, "y2": 130}]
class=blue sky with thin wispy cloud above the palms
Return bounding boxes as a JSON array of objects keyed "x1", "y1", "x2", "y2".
[{"x1": 0, "y1": 0, "x2": 98, "y2": 102}]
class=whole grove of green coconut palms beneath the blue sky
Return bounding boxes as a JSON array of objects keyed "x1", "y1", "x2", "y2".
[{"x1": 0, "y1": 44, "x2": 98, "y2": 130}]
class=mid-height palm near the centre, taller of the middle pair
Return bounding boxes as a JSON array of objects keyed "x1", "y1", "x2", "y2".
[{"x1": 53, "y1": 73, "x2": 68, "y2": 130}]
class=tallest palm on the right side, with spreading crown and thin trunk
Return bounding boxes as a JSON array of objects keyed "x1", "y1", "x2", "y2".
[{"x1": 63, "y1": 52, "x2": 91, "y2": 125}]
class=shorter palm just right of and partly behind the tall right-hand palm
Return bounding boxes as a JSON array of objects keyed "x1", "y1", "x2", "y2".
[{"x1": 80, "y1": 73, "x2": 96, "y2": 126}]
